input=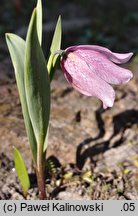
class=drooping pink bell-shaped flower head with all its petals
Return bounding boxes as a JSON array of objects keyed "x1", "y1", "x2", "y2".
[{"x1": 61, "y1": 45, "x2": 133, "y2": 108}]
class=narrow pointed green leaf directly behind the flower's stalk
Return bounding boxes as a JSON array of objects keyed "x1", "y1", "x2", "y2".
[{"x1": 47, "y1": 16, "x2": 62, "y2": 80}]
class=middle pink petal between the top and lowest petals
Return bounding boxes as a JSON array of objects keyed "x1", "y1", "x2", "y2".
[{"x1": 67, "y1": 49, "x2": 133, "y2": 85}]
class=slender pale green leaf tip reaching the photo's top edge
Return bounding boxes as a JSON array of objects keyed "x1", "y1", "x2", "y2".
[{"x1": 36, "y1": 0, "x2": 42, "y2": 45}]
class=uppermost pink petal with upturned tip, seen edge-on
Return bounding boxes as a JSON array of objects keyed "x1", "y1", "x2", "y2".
[{"x1": 67, "y1": 45, "x2": 133, "y2": 64}]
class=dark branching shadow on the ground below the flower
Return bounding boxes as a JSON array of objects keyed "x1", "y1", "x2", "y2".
[{"x1": 76, "y1": 109, "x2": 138, "y2": 169}]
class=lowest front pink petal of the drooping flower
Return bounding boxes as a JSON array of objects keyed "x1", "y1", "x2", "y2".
[{"x1": 61, "y1": 53, "x2": 115, "y2": 108}]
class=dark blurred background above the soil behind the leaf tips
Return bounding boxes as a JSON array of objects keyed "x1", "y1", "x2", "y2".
[{"x1": 0, "y1": 0, "x2": 138, "y2": 56}]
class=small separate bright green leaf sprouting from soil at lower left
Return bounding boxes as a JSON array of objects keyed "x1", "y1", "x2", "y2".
[{"x1": 14, "y1": 147, "x2": 30, "y2": 197}]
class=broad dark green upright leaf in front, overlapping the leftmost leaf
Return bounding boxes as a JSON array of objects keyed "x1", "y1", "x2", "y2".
[{"x1": 25, "y1": 9, "x2": 50, "y2": 148}]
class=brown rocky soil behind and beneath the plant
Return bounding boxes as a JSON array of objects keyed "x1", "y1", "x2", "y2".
[{"x1": 0, "y1": 55, "x2": 138, "y2": 200}]
